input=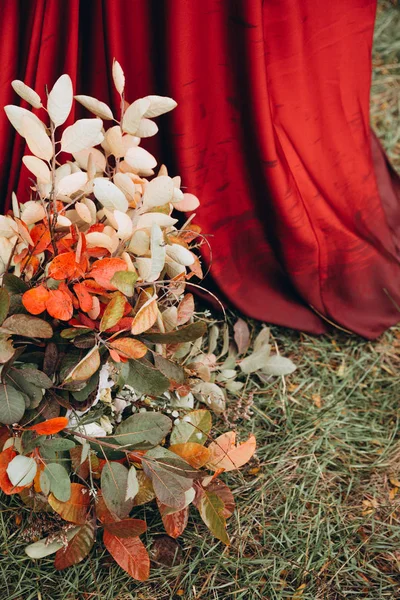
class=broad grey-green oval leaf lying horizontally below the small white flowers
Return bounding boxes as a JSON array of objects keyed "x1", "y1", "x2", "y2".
[{"x1": 114, "y1": 412, "x2": 172, "y2": 448}]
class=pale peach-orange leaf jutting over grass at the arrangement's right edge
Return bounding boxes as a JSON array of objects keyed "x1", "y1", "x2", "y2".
[{"x1": 208, "y1": 431, "x2": 256, "y2": 471}]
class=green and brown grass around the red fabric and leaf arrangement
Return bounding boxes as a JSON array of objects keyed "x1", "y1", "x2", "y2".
[{"x1": 0, "y1": 3, "x2": 400, "y2": 600}]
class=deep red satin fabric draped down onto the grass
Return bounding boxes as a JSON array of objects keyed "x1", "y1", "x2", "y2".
[{"x1": 0, "y1": 0, "x2": 400, "y2": 337}]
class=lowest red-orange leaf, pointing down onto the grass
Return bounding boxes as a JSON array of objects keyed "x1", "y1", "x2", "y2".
[{"x1": 103, "y1": 530, "x2": 150, "y2": 581}]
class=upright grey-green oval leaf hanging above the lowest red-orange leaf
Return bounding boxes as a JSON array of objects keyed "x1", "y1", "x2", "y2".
[{"x1": 101, "y1": 462, "x2": 133, "y2": 519}]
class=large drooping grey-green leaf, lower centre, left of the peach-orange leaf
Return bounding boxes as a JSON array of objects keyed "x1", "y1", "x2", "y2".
[{"x1": 142, "y1": 447, "x2": 193, "y2": 510}]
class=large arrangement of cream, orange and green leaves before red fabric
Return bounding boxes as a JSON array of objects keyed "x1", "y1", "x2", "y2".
[{"x1": 0, "y1": 61, "x2": 255, "y2": 580}]
